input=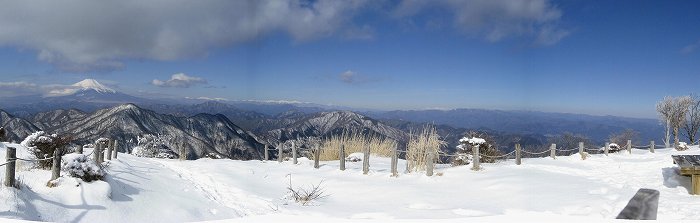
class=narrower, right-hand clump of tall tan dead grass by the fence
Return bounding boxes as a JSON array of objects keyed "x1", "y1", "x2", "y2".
[{"x1": 406, "y1": 126, "x2": 446, "y2": 172}]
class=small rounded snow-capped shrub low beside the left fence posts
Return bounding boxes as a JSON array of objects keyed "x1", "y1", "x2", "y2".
[{"x1": 61, "y1": 153, "x2": 104, "y2": 182}]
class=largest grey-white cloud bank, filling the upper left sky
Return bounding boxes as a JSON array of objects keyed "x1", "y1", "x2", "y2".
[{"x1": 0, "y1": 0, "x2": 368, "y2": 72}]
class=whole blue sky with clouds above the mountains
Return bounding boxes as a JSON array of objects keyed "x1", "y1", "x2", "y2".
[{"x1": 0, "y1": 0, "x2": 700, "y2": 118}]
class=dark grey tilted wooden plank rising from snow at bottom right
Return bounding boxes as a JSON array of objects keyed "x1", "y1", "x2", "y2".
[{"x1": 617, "y1": 188, "x2": 659, "y2": 220}]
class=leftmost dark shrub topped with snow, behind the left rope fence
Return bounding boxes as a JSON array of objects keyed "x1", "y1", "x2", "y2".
[{"x1": 20, "y1": 131, "x2": 72, "y2": 168}]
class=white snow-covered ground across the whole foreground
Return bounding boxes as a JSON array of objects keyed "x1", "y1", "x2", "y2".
[{"x1": 0, "y1": 144, "x2": 700, "y2": 222}]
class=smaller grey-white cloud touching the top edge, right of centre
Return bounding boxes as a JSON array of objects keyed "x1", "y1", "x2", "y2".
[{"x1": 393, "y1": 0, "x2": 570, "y2": 45}]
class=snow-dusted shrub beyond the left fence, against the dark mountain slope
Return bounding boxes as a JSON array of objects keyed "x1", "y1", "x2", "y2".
[{"x1": 131, "y1": 134, "x2": 180, "y2": 159}]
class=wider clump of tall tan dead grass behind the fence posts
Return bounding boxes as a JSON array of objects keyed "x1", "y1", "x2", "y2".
[{"x1": 319, "y1": 131, "x2": 397, "y2": 161}]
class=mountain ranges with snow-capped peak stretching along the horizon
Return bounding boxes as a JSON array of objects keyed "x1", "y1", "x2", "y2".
[{"x1": 0, "y1": 79, "x2": 662, "y2": 159}]
